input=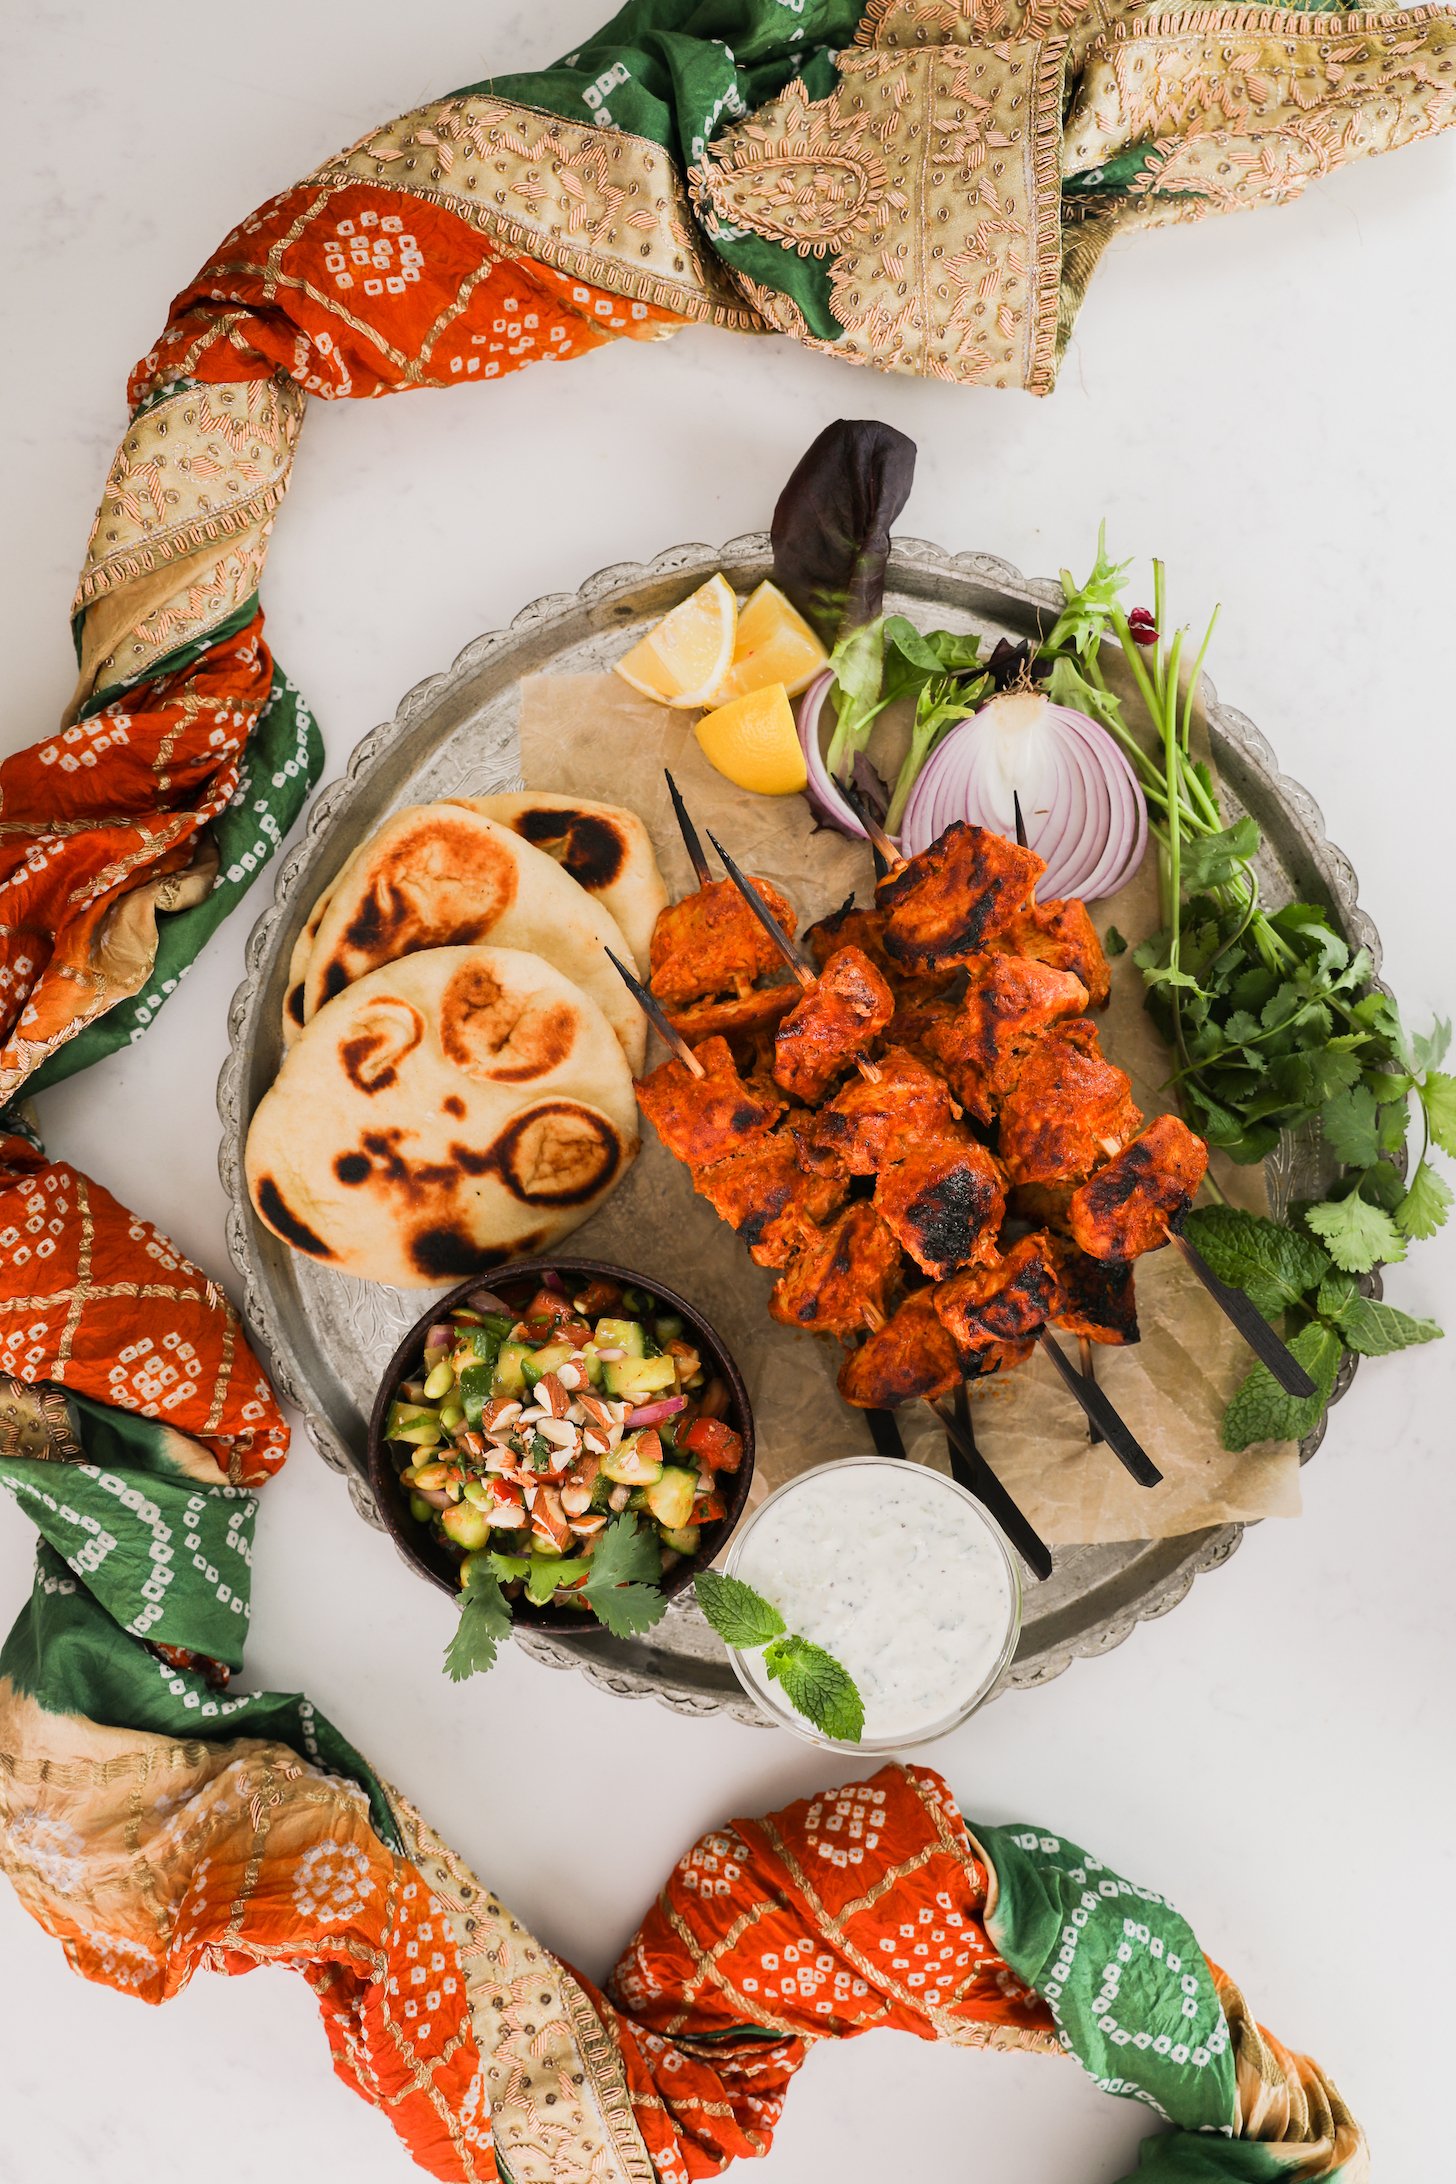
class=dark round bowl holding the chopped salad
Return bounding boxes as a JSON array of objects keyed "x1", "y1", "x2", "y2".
[{"x1": 369, "y1": 1258, "x2": 753, "y2": 1638}]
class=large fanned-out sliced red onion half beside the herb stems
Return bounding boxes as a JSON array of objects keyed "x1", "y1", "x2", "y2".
[{"x1": 899, "y1": 690, "x2": 1148, "y2": 902}]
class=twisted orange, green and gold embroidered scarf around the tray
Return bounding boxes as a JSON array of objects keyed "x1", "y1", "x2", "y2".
[{"x1": 0, "y1": 0, "x2": 1431, "y2": 2184}]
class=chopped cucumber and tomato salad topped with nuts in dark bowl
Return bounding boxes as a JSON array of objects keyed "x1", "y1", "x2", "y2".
[{"x1": 384, "y1": 1278, "x2": 742, "y2": 1621}]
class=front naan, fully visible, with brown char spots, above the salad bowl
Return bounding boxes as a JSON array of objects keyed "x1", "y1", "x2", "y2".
[{"x1": 244, "y1": 948, "x2": 637, "y2": 1289}]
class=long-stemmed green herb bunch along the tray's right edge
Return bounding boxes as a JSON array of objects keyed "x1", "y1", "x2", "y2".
[{"x1": 1037, "y1": 535, "x2": 1456, "y2": 1448}]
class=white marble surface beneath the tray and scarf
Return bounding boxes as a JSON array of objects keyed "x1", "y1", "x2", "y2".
[{"x1": 0, "y1": 0, "x2": 1456, "y2": 2184}]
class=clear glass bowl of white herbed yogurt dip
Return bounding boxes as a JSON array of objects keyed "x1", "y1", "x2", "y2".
[{"x1": 725, "y1": 1457, "x2": 1022, "y2": 1752}]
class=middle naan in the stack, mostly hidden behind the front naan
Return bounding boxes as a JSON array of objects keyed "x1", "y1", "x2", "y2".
[{"x1": 303, "y1": 802, "x2": 646, "y2": 1070}]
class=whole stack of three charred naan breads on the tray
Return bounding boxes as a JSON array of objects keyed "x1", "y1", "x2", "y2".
[{"x1": 247, "y1": 795, "x2": 668, "y2": 1289}]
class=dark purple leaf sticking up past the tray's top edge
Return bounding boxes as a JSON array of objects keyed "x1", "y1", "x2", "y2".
[{"x1": 773, "y1": 417, "x2": 915, "y2": 651}]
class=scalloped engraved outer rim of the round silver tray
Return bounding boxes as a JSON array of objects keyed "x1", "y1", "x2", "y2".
[{"x1": 218, "y1": 531, "x2": 1380, "y2": 1725}]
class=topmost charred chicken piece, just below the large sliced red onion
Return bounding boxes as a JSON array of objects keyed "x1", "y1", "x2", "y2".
[{"x1": 875, "y1": 819, "x2": 1046, "y2": 972}]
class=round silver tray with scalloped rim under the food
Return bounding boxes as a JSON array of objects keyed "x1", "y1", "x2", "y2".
[{"x1": 218, "y1": 533, "x2": 1380, "y2": 1721}]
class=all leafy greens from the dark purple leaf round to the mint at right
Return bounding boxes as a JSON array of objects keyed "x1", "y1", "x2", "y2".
[{"x1": 773, "y1": 419, "x2": 1456, "y2": 1448}]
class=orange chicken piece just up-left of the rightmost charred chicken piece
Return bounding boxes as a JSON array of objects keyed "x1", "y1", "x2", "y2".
[{"x1": 1000, "y1": 1016, "x2": 1142, "y2": 1184}]
